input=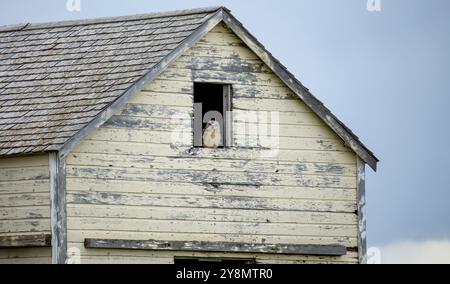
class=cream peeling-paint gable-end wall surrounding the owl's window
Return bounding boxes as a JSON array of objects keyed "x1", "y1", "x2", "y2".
[{"x1": 67, "y1": 22, "x2": 358, "y2": 263}]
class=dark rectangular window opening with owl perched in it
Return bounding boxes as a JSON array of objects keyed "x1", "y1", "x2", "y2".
[{"x1": 194, "y1": 83, "x2": 231, "y2": 148}]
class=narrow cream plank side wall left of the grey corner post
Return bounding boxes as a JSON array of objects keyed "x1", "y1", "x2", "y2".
[{"x1": 0, "y1": 155, "x2": 51, "y2": 263}]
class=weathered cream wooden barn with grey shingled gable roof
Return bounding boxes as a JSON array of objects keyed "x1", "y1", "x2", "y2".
[{"x1": 0, "y1": 7, "x2": 378, "y2": 263}]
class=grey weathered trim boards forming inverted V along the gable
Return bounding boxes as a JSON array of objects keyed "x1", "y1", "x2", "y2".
[{"x1": 59, "y1": 7, "x2": 379, "y2": 171}]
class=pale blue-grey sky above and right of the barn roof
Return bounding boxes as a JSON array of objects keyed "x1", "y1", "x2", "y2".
[{"x1": 0, "y1": 0, "x2": 450, "y2": 246}]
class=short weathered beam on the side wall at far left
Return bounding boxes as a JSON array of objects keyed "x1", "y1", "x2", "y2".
[{"x1": 0, "y1": 234, "x2": 52, "y2": 248}]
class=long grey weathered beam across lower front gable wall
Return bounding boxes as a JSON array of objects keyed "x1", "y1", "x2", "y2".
[{"x1": 84, "y1": 239, "x2": 347, "y2": 256}]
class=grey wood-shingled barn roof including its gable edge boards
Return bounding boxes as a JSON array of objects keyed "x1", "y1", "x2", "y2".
[{"x1": 0, "y1": 6, "x2": 378, "y2": 170}]
